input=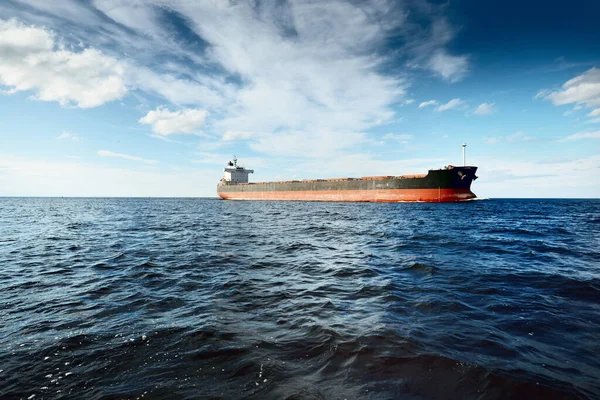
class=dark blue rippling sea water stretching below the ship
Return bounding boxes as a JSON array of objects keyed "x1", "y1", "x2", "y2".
[{"x1": 0, "y1": 198, "x2": 600, "y2": 399}]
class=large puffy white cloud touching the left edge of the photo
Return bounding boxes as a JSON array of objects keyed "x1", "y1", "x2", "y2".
[{"x1": 0, "y1": 20, "x2": 127, "y2": 108}]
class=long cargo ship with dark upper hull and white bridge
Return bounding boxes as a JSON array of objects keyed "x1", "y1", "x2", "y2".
[{"x1": 217, "y1": 146, "x2": 477, "y2": 202}]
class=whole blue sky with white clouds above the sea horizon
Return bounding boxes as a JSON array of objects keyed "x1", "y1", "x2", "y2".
[{"x1": 0, "y1": 0, "x2": 600, "y2": 198}]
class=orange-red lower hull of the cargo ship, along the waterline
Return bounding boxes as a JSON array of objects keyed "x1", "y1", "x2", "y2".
[{"x1": 218, "y1": 189, "x2": 477, "y2": 203}]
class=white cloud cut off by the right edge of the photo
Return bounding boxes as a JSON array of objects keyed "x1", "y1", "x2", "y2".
[{"x1": 535, "y1": 68, "x2": 600, "y2": 107}]
